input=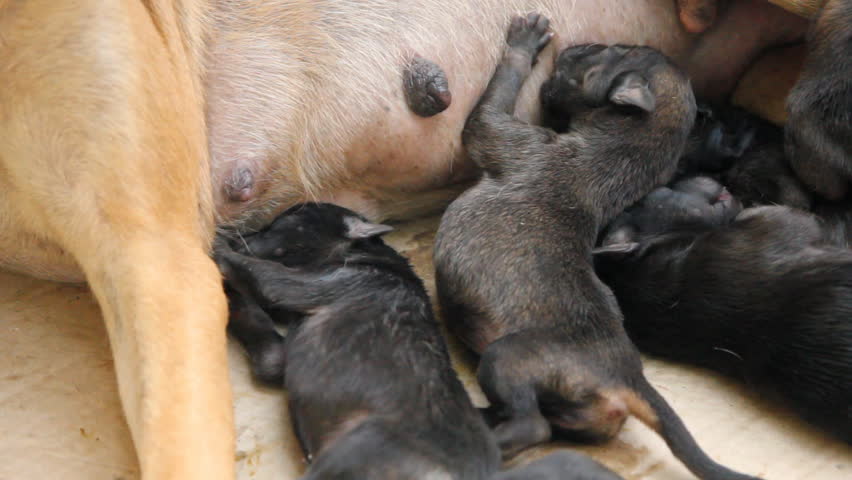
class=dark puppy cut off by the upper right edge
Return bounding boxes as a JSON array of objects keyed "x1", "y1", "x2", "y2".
[{"x1": 784, "y1": 0, "x2": 852, "y2": 200}]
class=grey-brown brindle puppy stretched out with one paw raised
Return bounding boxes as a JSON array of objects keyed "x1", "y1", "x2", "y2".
[{"x1": 434, "y1": 15, "x2": 747, "y2": 479}]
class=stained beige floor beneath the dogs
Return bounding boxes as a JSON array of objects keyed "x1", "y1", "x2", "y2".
[{"x1": 0, "y1": 219, "x2": 852, "y2": 480}]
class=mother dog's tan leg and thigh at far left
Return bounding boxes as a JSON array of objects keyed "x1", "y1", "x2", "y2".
[{"x1": 0, "y1": 0, "x2": 234, "y2": 480}]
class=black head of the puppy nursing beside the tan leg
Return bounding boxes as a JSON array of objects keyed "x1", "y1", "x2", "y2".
[{"x1": 235, "y1": 203, "x2": 393, "y2": 266}]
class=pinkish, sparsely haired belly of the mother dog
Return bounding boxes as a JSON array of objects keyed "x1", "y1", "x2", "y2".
[{"x1": 206, "y1": 0, "x2": 806, "y2": 228}]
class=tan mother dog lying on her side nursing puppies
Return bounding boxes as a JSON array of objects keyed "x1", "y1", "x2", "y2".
[{"x1": 0, "y1": 0, "x2": 808, "y2": 480}]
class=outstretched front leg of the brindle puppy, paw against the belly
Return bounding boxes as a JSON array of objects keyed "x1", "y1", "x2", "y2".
[{"x1": 462, "y1": 13, "x2": 553, "y2": 176}]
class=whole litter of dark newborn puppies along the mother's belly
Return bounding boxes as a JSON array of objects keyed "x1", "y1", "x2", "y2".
[{"x1": 214, "y1": 8, "x2": 852, "y2": 480}]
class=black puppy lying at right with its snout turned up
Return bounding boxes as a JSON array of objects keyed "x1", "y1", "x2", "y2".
[{"x1": 596, "y1": 178, "x2": 852, "y2": 442}]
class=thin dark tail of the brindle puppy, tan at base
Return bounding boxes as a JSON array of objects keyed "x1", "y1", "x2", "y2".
[{"x1": 627, "y1": 376, "x2": 759, "y2": 480}]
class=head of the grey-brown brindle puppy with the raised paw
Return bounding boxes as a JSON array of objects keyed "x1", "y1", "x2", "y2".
[{"x1": 541, "y1": 44, "x2": 695, "y2": 122}]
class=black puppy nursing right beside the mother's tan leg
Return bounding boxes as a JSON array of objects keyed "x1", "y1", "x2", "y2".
[{"x1": 216, "y1": 204, "x2": 618, "y2": 480}]
